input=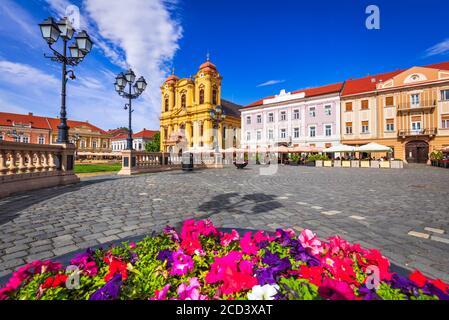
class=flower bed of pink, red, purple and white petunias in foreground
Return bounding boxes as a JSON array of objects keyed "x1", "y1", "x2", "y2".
[{"x1": 0, "y1": 220, "x2": 449, "y2": 300}]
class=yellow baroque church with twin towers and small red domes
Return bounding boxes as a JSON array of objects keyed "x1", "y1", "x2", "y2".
[{"x1": 160, "y1": 59, "x2": 241, "y2": 154}]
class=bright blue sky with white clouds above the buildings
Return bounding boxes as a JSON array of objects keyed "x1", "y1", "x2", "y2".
[{"x1": 0, "y1": 0, "x2": 449, "y2": 130}]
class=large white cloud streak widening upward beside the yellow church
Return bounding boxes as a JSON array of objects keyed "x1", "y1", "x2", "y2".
[{"x1": 84, "y1": 0, "x2": 182, "y2": 128}]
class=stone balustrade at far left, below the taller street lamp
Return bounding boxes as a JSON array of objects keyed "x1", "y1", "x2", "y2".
[{"x1": 0, "y1": 141, "x2": 79, "y2": 198}]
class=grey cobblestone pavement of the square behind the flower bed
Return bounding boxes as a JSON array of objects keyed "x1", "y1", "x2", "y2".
[{"x1": 0, "y1": 166, "x2": 449, "y2": 281}]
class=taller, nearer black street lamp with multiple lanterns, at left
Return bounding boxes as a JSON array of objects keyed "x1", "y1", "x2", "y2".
[{"x1": 39, "y1": 17, "x2": 93, "y2": 143}]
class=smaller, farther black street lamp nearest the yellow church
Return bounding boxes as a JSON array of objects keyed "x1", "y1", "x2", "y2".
[{"x1": 114, "y1": 69, "x2": 147, "y2": 150}]
